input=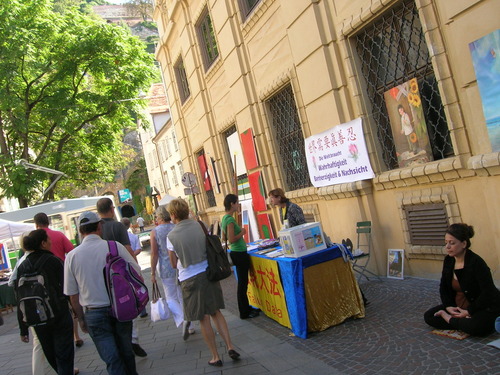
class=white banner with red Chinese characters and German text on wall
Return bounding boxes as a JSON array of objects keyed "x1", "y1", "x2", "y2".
[{"x1": 305, "y1": 118, "x2": 375, "y2": 187}]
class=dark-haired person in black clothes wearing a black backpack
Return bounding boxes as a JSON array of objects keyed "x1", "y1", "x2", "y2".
[{"x1": 16, "y1": 229, "x2": 75, "y2": 375}]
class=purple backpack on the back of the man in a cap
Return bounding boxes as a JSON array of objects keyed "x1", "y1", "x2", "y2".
[{"x1": 104, "y1": 241, "x2": 149, "y2": 322}]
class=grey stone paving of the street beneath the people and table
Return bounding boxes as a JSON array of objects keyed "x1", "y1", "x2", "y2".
[{"x1": 0, "y1": 251, "x2": 500, "y2": 375}]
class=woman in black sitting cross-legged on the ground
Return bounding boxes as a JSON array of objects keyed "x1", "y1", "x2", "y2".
[{"x1": 424, "y1": 224, "x2": 500, "y2": 335}]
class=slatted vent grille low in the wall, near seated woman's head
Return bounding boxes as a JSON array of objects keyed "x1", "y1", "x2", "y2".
[{"x1": 403, "y1": 203, "x2": 449, "y2": 245}]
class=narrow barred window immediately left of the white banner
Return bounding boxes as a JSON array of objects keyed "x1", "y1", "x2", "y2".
[{"x1": 266, "y1": 85, "x2": 311, "y2": 191}]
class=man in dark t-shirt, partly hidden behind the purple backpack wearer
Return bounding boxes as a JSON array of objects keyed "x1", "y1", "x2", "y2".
[{"x1": 97, "y1": 198, "x2": 148, "y2": 357}]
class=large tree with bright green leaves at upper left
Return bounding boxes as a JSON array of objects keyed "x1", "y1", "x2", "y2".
[{"x1": 0, "y1": 0, "x2": 155, "y2": 207}]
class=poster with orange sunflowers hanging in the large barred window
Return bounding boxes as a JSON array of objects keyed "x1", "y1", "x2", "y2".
[{"x1": 384, "y1": 78, "x2": 434, "y2": 167}]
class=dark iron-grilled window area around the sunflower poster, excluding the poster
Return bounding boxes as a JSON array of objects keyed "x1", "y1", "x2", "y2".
[{"x1": 354, "y1": 0, "x2": 453, "y2": 169}]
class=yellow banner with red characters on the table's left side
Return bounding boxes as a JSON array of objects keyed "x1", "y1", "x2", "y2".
[{"x1": 247, "y1": 257, "x2": 292, "y2": 328}]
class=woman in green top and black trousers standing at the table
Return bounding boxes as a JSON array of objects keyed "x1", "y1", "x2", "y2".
[{"x1": 221, "y1": 194, "x2": 259, "y2": 319}]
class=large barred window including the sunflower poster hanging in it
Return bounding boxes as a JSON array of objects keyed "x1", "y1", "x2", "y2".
[{"x1": 354, "y1": 0, "x2": 454, "y2": 169}]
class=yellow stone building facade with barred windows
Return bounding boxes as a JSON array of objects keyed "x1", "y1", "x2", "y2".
[{"x1": 154, "y1": 0, "x2": 500, "y2": 282}]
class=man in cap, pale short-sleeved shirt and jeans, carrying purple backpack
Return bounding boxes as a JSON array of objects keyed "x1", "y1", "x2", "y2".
[{"x1": 64, "y1": 211, "x2": 141, "y2": 375}]
